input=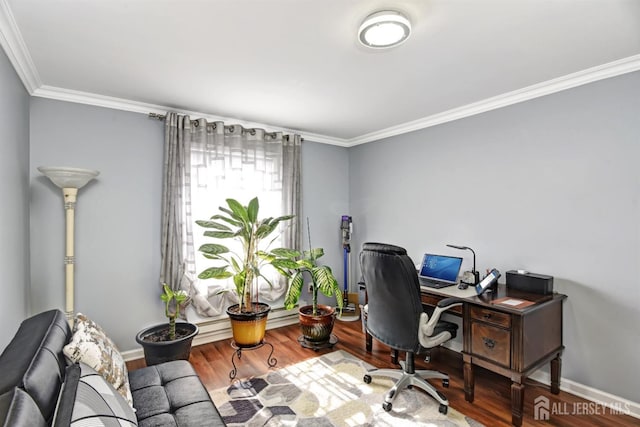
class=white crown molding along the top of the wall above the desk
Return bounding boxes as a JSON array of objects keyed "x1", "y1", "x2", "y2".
[{"x1": 348, "y1": 55, "x2": 640, "y2": 146}]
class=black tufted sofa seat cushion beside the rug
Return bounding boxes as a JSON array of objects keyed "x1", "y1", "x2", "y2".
[{"x1": 129, "y1": 360, "x2": 225, "y2": 427}]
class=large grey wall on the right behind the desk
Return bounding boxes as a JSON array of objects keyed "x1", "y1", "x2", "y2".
[{"x1": 349, "y1": 72, "x2": 640, "y2": 402}]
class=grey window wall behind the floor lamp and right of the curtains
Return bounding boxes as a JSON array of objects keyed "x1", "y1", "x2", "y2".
[{"x1": 30, "y1": 98, "x2": 348, "y2": 351}]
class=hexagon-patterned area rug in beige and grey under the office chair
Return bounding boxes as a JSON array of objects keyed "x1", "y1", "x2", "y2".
[{"x1": 210, "y1": 350, "x2": 482, "y2": 427}]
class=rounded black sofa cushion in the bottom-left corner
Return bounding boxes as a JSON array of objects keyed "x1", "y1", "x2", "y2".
[{"x1": 0, "y1": 387, "x2": 47, "y2": 427}]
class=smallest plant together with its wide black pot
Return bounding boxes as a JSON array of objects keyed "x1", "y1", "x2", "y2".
[{"x1": 136, "y1": 283, "x2": 198, "y2": 366}]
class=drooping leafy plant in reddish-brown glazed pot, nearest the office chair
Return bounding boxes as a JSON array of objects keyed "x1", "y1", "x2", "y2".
[{"x1": 284, "y1": 246, "x2": 343, "y2": 348}]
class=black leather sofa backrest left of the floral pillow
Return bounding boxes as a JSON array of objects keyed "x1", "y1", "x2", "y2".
[{"x1": 0, "y1": 310, "x2": 71, "y2": 422}]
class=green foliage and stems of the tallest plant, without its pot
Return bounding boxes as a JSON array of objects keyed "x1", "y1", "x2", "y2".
[{"x1": 196, "y1": 197, "x2": 300, "y2": 312}]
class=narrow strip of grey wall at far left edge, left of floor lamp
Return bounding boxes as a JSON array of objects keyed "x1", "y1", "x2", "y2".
[{"x1": 0, "y1": 49, "x2": 29, "y2": 349}]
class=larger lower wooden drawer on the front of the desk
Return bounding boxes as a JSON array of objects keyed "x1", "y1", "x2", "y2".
[{"x1": 471, "y1": 322, "x2": 511, "y2": 368}]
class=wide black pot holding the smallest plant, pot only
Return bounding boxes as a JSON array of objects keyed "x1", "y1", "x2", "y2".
[{"x1": 136, "y1": 322, "x2": 198, "y2": 366}]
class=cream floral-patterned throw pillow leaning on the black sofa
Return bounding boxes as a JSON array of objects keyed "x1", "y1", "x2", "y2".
[{"x1": 63, "y1": 313, "x2": 133, "y2": 407}]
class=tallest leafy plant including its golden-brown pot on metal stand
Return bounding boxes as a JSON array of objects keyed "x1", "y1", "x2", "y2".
[{"x1": 196, "y1": 197, "x2": 300, "y2": 348}]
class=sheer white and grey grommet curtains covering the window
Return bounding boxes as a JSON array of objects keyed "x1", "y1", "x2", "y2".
[{"x1": 161, "y1": 113, "x2": 302, "y2": 316}]
